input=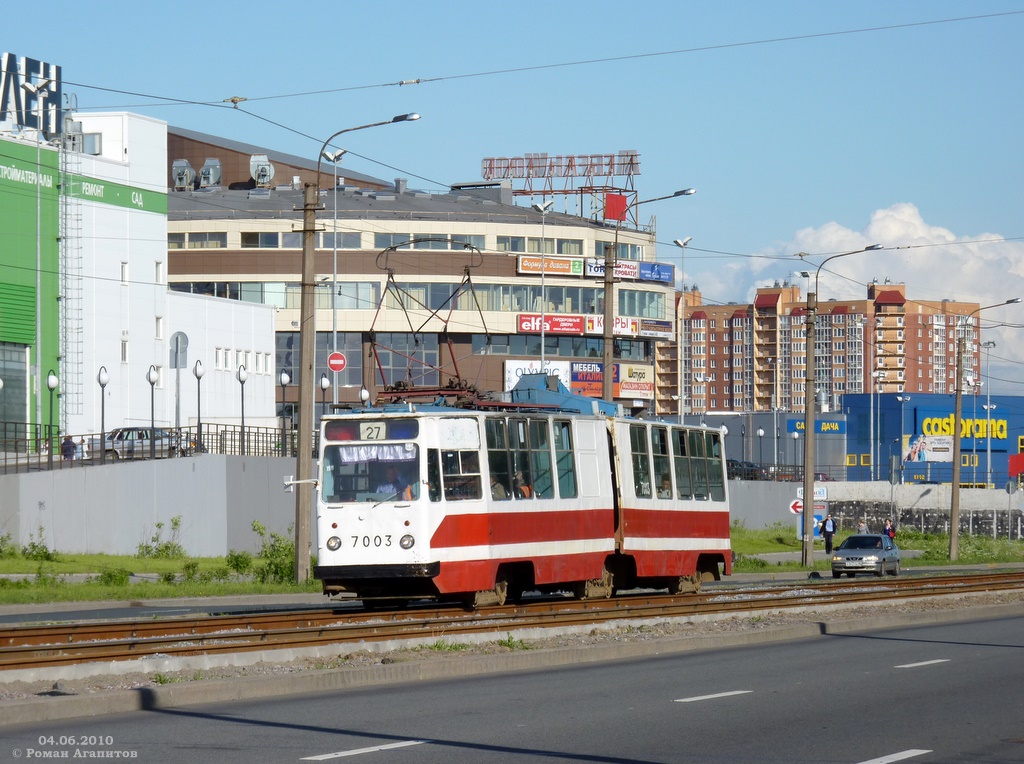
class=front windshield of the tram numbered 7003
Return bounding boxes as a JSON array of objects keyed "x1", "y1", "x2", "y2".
[{"x1": 321, "y1": 442, "x2": 420, "y2": 503}]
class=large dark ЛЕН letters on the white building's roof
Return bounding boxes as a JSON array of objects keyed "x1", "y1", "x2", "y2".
[{"x1": 0, "y1": 53, "x2": 60, "y2": 135}]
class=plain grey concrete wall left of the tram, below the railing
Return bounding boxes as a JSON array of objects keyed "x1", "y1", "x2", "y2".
[{"x1": 0, "y1": 454, "x2": 301, "y2": 557}]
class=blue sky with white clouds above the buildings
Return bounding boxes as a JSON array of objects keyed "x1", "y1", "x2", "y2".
[{"x1": 8, "y1": 0, "x2": 1024, "y2": 380}]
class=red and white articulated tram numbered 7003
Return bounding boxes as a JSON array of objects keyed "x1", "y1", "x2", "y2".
[{"x1": 314, "y1": 378, "x2": 731, "y2": 606}]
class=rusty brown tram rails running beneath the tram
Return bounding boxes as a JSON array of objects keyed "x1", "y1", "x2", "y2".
[{"x1": 0, "y1": 571, "x2": 1024, "y2": 667}]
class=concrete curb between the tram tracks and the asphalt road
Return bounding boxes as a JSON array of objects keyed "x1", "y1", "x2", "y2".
[{"x1": 0, "y1": 603, "x2": 1024, "y2": 728}]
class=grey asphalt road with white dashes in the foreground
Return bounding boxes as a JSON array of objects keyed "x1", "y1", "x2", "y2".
[{"x1": 0, "y1": 616, "x2": 1024, "y2": 764}]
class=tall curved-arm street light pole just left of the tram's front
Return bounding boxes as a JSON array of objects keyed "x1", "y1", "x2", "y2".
[{"x1": 295, "y1": 114, "x2": 420, "y2": 584}]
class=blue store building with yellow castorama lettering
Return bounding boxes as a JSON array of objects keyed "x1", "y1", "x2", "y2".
[{"x1": 843, "y1": 393, "x2": 1024, "y2": 487}]
